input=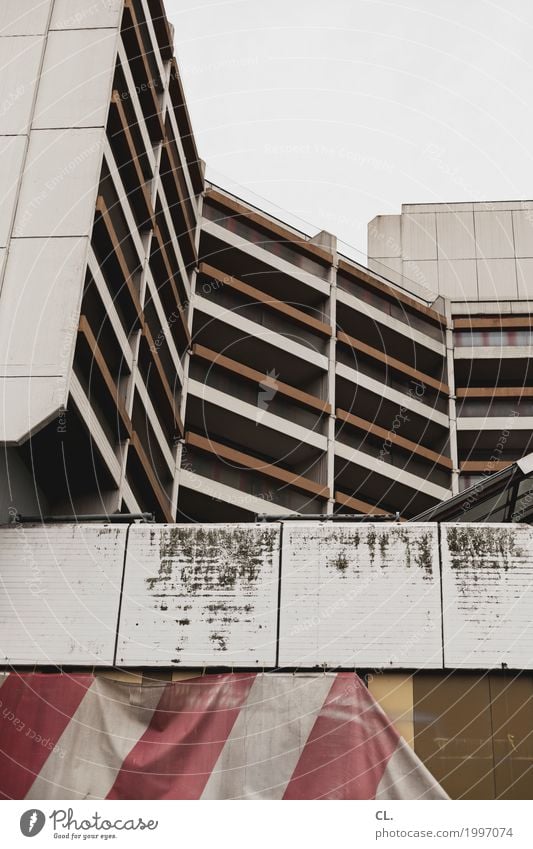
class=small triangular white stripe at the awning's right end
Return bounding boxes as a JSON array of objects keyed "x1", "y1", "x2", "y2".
[{"x1": 376, "y1": 737, "x2": 448, "y2": 799}]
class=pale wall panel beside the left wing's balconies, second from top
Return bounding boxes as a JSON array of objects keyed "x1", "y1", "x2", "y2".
[{"x1": 32, "y1": 29, "x2": 117, "y2": 129}]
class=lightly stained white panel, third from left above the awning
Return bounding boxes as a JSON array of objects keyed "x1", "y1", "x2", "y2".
[{"x1": 279, "y1": 522, "x2": 442, "y2": 668}]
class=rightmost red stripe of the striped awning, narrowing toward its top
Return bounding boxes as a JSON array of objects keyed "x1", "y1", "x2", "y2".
[{"x1": 283, "y1": 672, "x2": 399, "y2": 799}]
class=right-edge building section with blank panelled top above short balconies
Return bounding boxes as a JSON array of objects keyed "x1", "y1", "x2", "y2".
[{"x1": 368, "y1": 201, "x2": 533, "y2": 489}]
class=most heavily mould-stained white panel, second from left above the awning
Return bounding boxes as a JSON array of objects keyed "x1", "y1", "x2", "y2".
[{"x1": 117, "y1": 524, "x2": 280, "y2": 668}]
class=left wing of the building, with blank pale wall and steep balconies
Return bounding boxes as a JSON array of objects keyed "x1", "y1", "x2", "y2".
[{"x1": 0, "y1": 0, "x2": 203, "y2": 521}]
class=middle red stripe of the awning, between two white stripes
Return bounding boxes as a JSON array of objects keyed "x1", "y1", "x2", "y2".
[{"x1": 108, "y1": 673, "x2": 255, "y2": 799}]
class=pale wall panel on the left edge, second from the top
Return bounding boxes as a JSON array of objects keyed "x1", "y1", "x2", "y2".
[{"x1": 0, "y1": 35, "x2": 44, "y2": 136}]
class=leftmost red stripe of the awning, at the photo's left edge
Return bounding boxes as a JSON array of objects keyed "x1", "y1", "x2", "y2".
[{"x1": 0, "y1": 672, "x2": 94, "y2": 799}]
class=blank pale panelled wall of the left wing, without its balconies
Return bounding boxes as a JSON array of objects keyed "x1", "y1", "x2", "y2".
[{"x1": 0, "y1": 2, "x2": 120, "y2": 445}]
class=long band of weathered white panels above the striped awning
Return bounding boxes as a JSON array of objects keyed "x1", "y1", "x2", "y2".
[{"x1": 0, "y1": 521, "x2": 533, "y2": 669}]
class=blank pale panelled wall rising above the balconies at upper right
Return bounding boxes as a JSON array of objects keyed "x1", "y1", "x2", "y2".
[{"x1": 368, "y1": 201, "x2": 533, "y2": 301}]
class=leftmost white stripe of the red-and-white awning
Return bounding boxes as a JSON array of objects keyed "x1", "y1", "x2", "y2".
[{"x1": 26, "y1": 678, "x2": 163, "y2": 799}]
